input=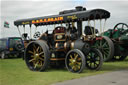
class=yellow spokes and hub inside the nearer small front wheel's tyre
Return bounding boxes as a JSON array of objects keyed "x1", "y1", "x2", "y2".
[{"x1": 67, "y1": 52, "x2": 82, "y2": 72}]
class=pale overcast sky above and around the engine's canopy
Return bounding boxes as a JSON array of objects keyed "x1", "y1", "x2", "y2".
[{"x1": 0, "y1": 0, "x2": 128, "y2": 37}]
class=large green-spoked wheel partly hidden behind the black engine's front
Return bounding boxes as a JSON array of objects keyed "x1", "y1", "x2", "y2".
[{"x1": 95, "y1": 36, "x2": 114, "y2": 61}]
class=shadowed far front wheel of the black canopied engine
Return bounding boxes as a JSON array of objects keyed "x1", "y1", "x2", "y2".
[{"x1": 86, "y1": 48, "x2": 103, "y2": 70}]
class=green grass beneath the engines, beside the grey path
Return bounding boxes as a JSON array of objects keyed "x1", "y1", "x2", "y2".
[{"x1": 0, "y1": 59, "x2": 128, "y2": 85}]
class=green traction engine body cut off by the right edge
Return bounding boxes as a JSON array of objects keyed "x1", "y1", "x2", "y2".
[{"x1": 104, "y1": 23, "x2": 128, "y2": 60}]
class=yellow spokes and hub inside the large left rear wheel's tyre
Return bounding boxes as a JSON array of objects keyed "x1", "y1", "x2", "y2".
[{"x1": 26, "y1": 43, "x2": 45, "y2": 70}]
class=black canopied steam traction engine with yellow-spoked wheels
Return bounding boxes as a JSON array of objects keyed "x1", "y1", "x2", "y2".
[{"x1": 14, "y1": 6, "x2": 110, "y2": 73}]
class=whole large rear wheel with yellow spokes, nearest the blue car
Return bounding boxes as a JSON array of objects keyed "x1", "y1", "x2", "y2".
[{"x1": 25, "y1": 40, "x2": 50, "y2": 71}]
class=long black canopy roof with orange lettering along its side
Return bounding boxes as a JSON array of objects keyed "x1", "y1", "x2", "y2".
[{"x1": 14, "y1": 8, "x2": 110, "y2": 27}]
